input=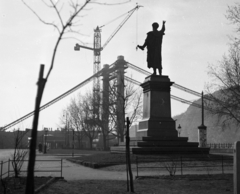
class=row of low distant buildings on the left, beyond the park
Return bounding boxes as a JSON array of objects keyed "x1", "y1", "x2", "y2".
[{"x1": 0, "y1": 129, "x2": 119, "y2": 150}]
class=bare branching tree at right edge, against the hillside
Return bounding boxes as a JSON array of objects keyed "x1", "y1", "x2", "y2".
[{"x1": 205, "y1": 3, "x2": 240, "y2": 127}]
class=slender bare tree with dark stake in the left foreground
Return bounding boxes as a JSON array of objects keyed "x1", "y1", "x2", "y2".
[{"x1": 22, "y1": 0, "x2": 90, "y2": 194}]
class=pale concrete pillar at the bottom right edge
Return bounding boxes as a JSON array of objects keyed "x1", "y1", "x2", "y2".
[{"x1": 233, "y1": 141, "x2": 240, "y2": 194}]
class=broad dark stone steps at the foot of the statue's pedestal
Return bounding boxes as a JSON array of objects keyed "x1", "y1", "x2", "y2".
[{"x1": 111, "y1": 136, "x2": 209, "y2": 155}]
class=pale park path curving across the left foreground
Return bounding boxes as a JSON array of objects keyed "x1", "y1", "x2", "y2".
[{"x1": 0, "y1": 150, "x2": 129, "y2": 180}]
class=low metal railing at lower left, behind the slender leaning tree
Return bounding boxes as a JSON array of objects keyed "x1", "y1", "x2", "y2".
[{"x1": 0, "y1": 159, "x2": 63, "y2": 179}]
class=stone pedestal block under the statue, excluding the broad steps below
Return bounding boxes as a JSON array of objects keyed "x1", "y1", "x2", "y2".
[{"x1": 137, "y1": 75, "x2": 178, "y2": 137}]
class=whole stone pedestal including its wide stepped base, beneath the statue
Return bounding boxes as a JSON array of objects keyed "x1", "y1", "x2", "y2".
[{"x1": 111, "y1": 75, "x2": 209, "y2": 155}]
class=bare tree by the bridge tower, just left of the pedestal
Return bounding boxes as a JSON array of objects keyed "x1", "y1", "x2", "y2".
[{"x1": 86, "y1": 77, "x2": 142, "y2": 150}]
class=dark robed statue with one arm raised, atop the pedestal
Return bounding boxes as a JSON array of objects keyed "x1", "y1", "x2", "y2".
[{"x1": 137, "y1": 21, "x2": 166, "y2": 75}]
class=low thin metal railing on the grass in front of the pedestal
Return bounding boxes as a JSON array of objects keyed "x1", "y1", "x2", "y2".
[{"x1": 136, "y1": 155, "x2": 233, "y2": 178}]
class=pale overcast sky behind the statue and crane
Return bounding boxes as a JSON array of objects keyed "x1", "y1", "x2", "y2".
[{"x1": 0, "y1": 0, "x2": 236, "y2": 129}]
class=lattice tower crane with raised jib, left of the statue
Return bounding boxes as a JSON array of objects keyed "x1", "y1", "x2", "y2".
[{"x1": 74, "y1": 5, "x2": 142, "y2": 115}]
